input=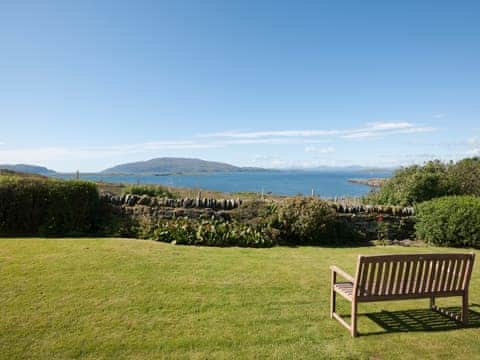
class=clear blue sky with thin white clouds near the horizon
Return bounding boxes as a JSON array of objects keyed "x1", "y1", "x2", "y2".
[{"x1": 0, "y1": 0, "x2": 480, "y2": 172}]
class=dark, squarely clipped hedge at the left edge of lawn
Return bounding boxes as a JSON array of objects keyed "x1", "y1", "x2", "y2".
[{"x1": 0, "y1": 177, "x2": 100, "y2": 235}]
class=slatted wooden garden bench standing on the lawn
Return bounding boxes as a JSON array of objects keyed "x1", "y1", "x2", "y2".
[{"x1": 330, "y1": 253, "x2": 475, "y2": 337}]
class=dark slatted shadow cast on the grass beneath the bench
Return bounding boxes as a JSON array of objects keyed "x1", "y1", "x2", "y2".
[{"x1": 360, "y1": 307, "x2": 480, "y2": 336}]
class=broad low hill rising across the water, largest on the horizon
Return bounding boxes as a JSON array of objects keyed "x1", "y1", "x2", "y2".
[{"x1": 102, "y1": 158, "x2": 263, "y2": 174}]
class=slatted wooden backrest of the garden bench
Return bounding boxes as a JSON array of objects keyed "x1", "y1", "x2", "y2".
[{"x1": 355, "y1": 253, "x2": 475, "y2": 300}]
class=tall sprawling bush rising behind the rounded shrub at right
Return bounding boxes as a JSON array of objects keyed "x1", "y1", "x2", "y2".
[{"x1": 364, "y1": 158, "x2": 480, "y2": 206}]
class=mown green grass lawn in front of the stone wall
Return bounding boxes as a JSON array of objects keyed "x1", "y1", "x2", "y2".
[{"x1": 0, "y1": 239, "x2": 480, "y2": 359}]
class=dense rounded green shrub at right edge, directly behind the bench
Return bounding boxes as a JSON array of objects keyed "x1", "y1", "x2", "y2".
[{"x1": 415, "y1": 196, "x2": 480, "y2": 248}]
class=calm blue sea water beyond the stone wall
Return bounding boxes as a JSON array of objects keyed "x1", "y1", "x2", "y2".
[{"x1": 59, "y1": 170, "x2": 392, "y2": 198}]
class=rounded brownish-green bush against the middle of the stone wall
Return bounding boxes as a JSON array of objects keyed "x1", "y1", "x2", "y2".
[{"x1": 272, "y1": 197, "x2": 345, "y2": 245}]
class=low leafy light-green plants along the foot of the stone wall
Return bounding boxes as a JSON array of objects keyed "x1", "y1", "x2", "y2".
[{"x1": 141, "y1": 219, "x2": 276, "y2": 247}]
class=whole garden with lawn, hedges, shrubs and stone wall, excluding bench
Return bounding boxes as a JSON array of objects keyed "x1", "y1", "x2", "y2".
[{"x1": 0, "y1": 159, "x2": 480, "y2": 359}]
